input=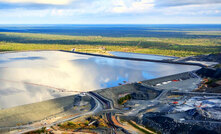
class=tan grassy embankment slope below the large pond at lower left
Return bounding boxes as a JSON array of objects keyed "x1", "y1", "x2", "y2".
[{"x1": 0, "y1": 95, "x2": 79, "y2": 129}]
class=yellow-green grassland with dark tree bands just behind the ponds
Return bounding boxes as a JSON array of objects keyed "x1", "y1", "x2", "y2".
[{"x1": 0, "y1": 32, "x2": 221, "y2": 57}]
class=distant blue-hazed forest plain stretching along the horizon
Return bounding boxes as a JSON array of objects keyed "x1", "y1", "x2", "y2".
[{"x1": 0, "y1": 24, "x2": 221, "y2": 38}]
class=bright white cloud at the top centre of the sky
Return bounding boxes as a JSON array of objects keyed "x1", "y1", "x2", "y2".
[{"x1": 46, "y1": 0, "x2": 154, "y2": 16}]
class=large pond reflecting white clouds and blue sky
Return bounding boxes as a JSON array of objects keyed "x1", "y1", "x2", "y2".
[{"x1": 0, "y1": 51, "x2": 199, "y2": 109}]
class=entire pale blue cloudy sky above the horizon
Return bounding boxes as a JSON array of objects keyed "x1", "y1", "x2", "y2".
[{"x1": 0, "y1": 0, "x2": 221, "y2": 24}]
